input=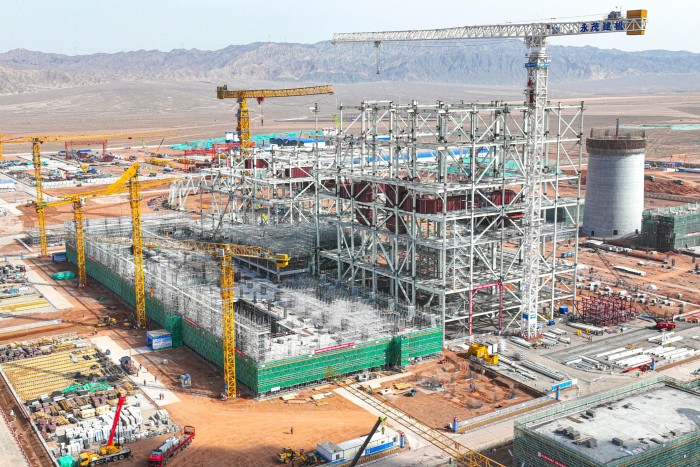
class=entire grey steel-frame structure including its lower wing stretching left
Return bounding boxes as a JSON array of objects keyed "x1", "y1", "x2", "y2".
[{"x1": 169, "y1": 101, "x2": 583, "y2": 339}]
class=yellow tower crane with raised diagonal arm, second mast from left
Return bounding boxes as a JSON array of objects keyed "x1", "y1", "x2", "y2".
[{"x1": 37, "y1": 164, "x2": 177, "y2": 287}]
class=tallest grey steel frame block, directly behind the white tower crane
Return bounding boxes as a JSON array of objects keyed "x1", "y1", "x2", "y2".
[{"x1": 317, "y1": 101, "x2": 583, "y2": 338}]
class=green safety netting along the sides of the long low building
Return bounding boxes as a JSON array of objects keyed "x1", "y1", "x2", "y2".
[{"x1": 66, "y1": 245, "x2": 442, "y2": 396}]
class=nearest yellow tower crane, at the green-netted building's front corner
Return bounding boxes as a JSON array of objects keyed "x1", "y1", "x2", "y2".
[{"x1": 100, "y1": 237, "x2": 290, "y2": 399}]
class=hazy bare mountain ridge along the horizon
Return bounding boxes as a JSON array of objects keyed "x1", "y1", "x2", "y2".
[{"x1": 0, "y1": 40, "x2": 700, "y2": 94}]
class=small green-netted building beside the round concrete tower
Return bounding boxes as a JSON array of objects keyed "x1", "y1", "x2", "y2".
[{"x1": 640, "y1": 203, "x2": 700, "y2": 251}]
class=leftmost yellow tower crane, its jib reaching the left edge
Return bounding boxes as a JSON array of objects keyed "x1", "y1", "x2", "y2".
[{"x1": 0, "y1": 130, "x2": 176, "y2": 256}]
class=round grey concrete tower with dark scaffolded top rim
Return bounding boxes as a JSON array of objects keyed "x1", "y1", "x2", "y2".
[{"x1": 582, "y1": 128, "x2": 647, "y2": 237}]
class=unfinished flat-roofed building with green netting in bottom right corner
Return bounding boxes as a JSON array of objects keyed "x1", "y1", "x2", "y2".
[{"x1": 513, "y1": 376, "x2": 700, "y2": 467}]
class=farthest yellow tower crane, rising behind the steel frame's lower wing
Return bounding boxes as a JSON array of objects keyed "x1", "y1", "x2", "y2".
[{"x1": 216, "y1": 85, "x2": 333, "y2": 155}]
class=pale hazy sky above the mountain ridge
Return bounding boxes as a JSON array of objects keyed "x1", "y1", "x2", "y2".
[{"x1": 0, "y1": 0, "x2": 700, "y2": 55}]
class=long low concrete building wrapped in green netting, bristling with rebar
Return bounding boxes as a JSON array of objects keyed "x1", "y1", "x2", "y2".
[{"x1": 66, "y1": 214, "x2": 442, "y2": 397}]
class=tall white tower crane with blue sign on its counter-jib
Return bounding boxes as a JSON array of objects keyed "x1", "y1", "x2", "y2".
[{"x1": 332, "y1": 10, "x2": 647, "y2": 339}]
